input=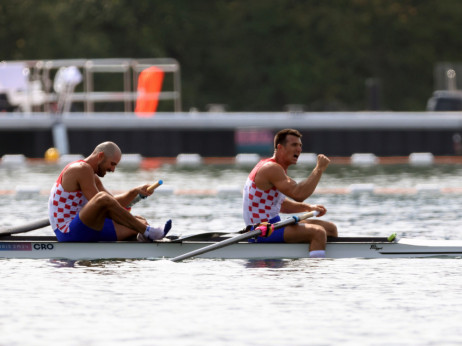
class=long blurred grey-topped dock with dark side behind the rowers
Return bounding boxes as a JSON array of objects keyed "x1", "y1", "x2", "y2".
[{"x1": 0, "y1": 112, "x2": 462, "y2": 158}]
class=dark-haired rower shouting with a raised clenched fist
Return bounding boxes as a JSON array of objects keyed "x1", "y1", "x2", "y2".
[{"x1": 243, "y1": 129, "x2": 337, "y2": 257}]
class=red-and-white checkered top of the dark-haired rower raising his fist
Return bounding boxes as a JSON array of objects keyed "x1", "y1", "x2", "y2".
[{"x1": 243, "y1": 158, "x2": 286, "y2": 225}]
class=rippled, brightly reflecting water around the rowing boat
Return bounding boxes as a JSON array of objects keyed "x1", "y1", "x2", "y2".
[{"x1": 0, "y1": 165, "x2": 462, "y2": 345}]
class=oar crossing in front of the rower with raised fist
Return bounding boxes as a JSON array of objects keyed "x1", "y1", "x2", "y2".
[{"x1": 171, "y1": 211, "x2": 319, "y2": 262}]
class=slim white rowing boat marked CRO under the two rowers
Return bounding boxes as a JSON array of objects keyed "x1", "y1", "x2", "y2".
[{"x1": 0, "y1": 232, "x2": 462, "y2": 260}]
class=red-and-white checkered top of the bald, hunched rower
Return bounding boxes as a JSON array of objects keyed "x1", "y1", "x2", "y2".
[{"x1": 48, "y1": 161, "x2": 88, "y2": 233}]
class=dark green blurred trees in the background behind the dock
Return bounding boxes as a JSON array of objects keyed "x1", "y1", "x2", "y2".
[{"x1": 0, "y1": 0, "x2": 462, "y2": 112}]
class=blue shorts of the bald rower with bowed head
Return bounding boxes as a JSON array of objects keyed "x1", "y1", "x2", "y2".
[{"x1": 55, "y1": 215, "x2": 117, "y2": 242}]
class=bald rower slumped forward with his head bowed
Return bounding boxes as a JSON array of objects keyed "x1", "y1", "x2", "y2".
[{"x1": 48, "y1": 142, "x2": 171, "y2": 242}]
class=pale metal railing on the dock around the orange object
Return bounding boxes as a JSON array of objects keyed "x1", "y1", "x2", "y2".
[{"x1": 0, "y1": 58, "x2": 181, "y2": 113}]
